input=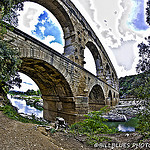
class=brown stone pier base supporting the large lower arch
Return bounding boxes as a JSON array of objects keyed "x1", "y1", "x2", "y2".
[{"x1": 42, "y1": 96, "x2": 78, "y2": 124}]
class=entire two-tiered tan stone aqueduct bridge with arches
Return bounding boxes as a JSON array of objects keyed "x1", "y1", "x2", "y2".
[{"x1": 6, "y1": 0, "x2": 119, "y2": 123}]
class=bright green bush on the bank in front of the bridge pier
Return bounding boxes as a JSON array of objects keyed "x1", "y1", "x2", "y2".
[{"x1": 70, "y1": 107, "x2": 114, "y2": 145}]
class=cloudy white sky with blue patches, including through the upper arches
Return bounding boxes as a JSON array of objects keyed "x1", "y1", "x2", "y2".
[{"x1": 12, "y1": 0, "x2": 150, "y2": 91}]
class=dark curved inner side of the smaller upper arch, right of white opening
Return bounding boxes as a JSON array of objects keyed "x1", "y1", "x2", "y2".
[{"x1": 86, "y1": 41, "x2": 103, "y2": 77}]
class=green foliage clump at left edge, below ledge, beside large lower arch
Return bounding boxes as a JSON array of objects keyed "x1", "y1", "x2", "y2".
[{"x1": 0, "y1": 40, "x2": 21, "y2": 94}]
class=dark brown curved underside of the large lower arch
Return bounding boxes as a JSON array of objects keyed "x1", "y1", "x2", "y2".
[{"x1": 20, "y1": 58, "x2": 73, "y2": 97}]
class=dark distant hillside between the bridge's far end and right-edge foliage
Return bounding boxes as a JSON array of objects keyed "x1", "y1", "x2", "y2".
[{"x1": 119, "y1": 72, "x2": 150, "y2": 98}]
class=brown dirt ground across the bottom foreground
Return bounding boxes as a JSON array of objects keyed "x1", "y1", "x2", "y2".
[{"x1": 0, "y1": 111, "x2": 150, "y2": 150}]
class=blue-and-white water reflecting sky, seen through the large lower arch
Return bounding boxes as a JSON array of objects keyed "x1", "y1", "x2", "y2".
[{"x1": 8, "y1": 96, "x2": 43, "y2": 117}]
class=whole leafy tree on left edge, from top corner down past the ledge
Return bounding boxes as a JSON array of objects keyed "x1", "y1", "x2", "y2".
[{"x1": 0, "y1": 0, "x2": 24, "y2": 101}]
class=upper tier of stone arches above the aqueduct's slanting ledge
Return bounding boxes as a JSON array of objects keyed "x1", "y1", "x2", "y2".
[{"x1": 19, "y1": 0, "x2": 118, "y2": 89}]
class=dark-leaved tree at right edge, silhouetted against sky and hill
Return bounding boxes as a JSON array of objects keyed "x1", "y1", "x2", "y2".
[{"x1": 132, "y1": 0, "x2": 150, "y2": 99}]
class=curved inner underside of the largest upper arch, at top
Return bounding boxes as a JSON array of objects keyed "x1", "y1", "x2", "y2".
[{"x1": 25, "y1": 0, "x2": 75, "y2": 56}]
